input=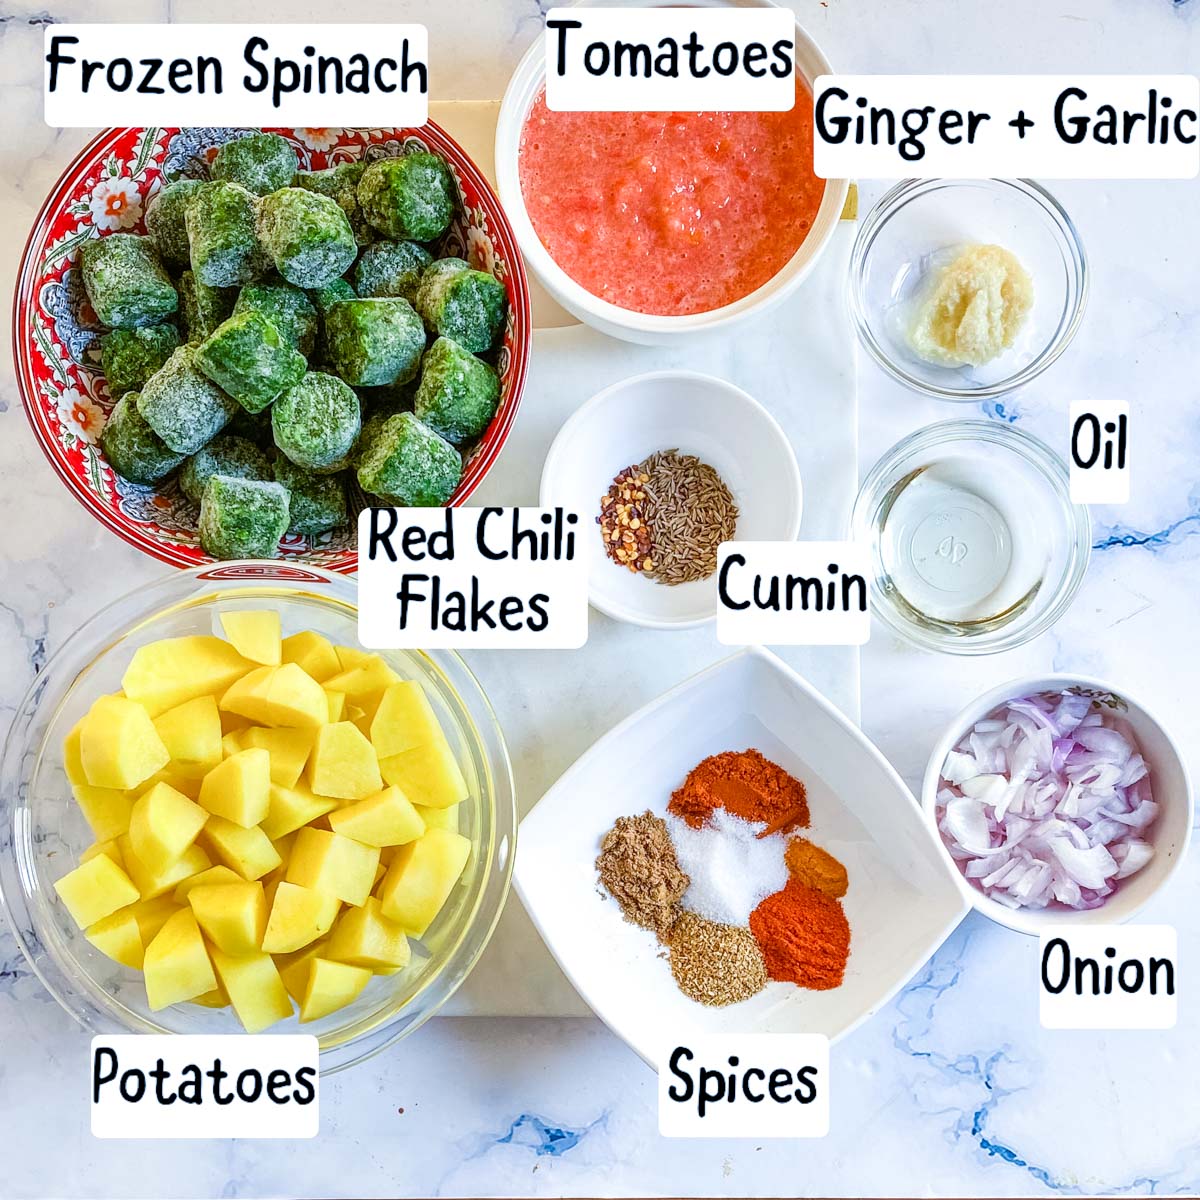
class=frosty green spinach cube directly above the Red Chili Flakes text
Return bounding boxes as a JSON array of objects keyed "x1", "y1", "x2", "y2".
[{"x1": 358, "y1": 413, "x2": 462, "y2": 508}]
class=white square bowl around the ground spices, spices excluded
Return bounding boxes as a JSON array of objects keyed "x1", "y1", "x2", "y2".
[{"x1": 514, "y1": 649, "x2": 967, "y2": 1067}]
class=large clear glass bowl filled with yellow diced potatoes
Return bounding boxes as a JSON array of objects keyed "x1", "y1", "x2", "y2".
[{"x1": 0, "y1": 562, "x2": 516, "y2": 1073}]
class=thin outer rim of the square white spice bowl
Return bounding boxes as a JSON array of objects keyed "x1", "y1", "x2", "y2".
[{"x1": 512, "y1": 646, "x2": 970, "y2": 1070}]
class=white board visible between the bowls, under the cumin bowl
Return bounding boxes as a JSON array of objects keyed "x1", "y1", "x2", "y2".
[{"x1": 430, "y1": 103, "x2": 859, "y2": 1016}]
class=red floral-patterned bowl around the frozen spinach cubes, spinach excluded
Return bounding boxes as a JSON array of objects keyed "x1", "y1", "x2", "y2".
[{"x1": 13, "y1": 121, "x2": 533, "y2": 571}]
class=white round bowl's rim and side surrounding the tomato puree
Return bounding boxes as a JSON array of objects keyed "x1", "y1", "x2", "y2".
[{"x1": 494, "y1": 0, "x2": 850, "y2": 340}]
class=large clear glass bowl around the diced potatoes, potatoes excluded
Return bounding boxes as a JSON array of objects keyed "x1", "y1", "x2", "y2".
[{"x1": 0, "y1": 562, "x2": 516, "y2": 1074}]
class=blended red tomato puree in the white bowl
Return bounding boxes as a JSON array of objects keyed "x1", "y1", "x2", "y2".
[{"x1": 518, "y1": 79, "x2": 824, "y2": 316}]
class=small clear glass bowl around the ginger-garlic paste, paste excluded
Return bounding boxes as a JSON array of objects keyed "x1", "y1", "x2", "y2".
[{"x1": 850, "y1": 179, "x2": 1087, "y2": 401}]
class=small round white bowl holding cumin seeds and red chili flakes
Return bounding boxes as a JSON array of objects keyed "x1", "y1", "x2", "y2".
[{"x1": 541, "y1": 371, "x2": 803, "y2": 629}]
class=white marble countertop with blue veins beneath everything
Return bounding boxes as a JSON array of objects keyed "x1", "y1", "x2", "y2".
[{"x1": 0, "y1": 0, "x2": 1200, "y2": 1198}]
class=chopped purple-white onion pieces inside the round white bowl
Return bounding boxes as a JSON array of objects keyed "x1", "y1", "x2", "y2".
[{"x1": 937, "y1": 691, "x2": 1158, "y2": 910}]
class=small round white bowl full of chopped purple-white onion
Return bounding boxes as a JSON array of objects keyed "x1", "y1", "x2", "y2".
[{"x1": 922, "y1": 674, "x2": 1193, "y2": 934}]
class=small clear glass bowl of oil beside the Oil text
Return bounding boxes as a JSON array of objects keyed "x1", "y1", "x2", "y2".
[{"x1": 851, "y1": 420, "x2": 1092, "y2": 654}]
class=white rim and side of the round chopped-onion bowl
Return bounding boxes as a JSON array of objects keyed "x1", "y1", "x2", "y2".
[{"x1": 920, "y1": 671, "x2": 1195, "y2": 937}]
